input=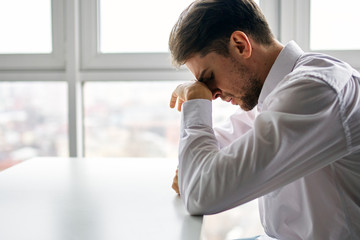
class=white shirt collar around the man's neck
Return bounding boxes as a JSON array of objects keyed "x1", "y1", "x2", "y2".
[{"x1": 258, "y1": 41, "x2": 304, "y2": 109}]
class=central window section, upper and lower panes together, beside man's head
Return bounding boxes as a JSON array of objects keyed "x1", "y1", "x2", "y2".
[{"x1": 82, "y1": 0, "x2": 242, "y2": 157}]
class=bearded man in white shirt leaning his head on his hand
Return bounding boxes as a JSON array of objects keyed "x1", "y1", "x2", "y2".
[{"x1": 169, "y1": 0, "x2": 360, "y2": 240}]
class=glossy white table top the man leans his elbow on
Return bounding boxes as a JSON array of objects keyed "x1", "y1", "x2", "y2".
[{"x1": 0, "y1": 158, "x2": 202, "y2": 240}]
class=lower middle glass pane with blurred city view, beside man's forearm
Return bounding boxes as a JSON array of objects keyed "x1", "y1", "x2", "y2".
[{"x1": 84, "y1": 81, "x2": 237, "y2": 158}]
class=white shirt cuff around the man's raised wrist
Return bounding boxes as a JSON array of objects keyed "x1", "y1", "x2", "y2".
[{"x1": 181, "y1": 99, "x2": 212, "y2": 129}]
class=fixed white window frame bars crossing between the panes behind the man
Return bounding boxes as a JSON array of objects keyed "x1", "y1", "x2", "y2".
[{"x1": 0, "y1": 0, "x2": 360, "y2": 161}]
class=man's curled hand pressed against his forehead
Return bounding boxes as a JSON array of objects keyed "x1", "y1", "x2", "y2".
[{"x1": 170, "y1": 81, "x2": 212, "y2": 112}]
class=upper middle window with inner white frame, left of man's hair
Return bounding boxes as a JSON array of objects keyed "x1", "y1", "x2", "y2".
[{"x1": 82, "y1": 0, "x2": 195, "y2": 70}]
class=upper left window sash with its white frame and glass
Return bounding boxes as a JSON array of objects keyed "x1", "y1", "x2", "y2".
[{"x1": 0, "y1": 0, "x2": 64, "y2": 70}]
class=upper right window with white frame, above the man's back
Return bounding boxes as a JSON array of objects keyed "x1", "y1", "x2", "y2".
[{"x1": 273, "y1": 0, "x2": 360, "y2": 69}]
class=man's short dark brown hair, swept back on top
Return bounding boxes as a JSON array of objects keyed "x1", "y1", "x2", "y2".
[{"x1": 169, "y1": 0, "x2": 274, "y2": 66}]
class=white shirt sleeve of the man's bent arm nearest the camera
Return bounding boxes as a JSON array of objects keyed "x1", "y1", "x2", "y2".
[{"x1": 179, "y1": 76, "x2": 347, "y2": 215}]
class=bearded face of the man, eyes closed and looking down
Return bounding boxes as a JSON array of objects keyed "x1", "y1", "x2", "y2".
[{"x1": 185, "y1": 52, "x2": 262, "y2": 111}]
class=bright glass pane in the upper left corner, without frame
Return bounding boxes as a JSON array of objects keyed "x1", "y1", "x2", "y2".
[{"x1": 0, "y1": 0, "x2": 52, "y2": 54}]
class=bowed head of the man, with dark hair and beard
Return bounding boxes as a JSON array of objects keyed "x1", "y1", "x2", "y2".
[{"x1": 169, "y1": 0, "x2": 281, "y2": 110}]
